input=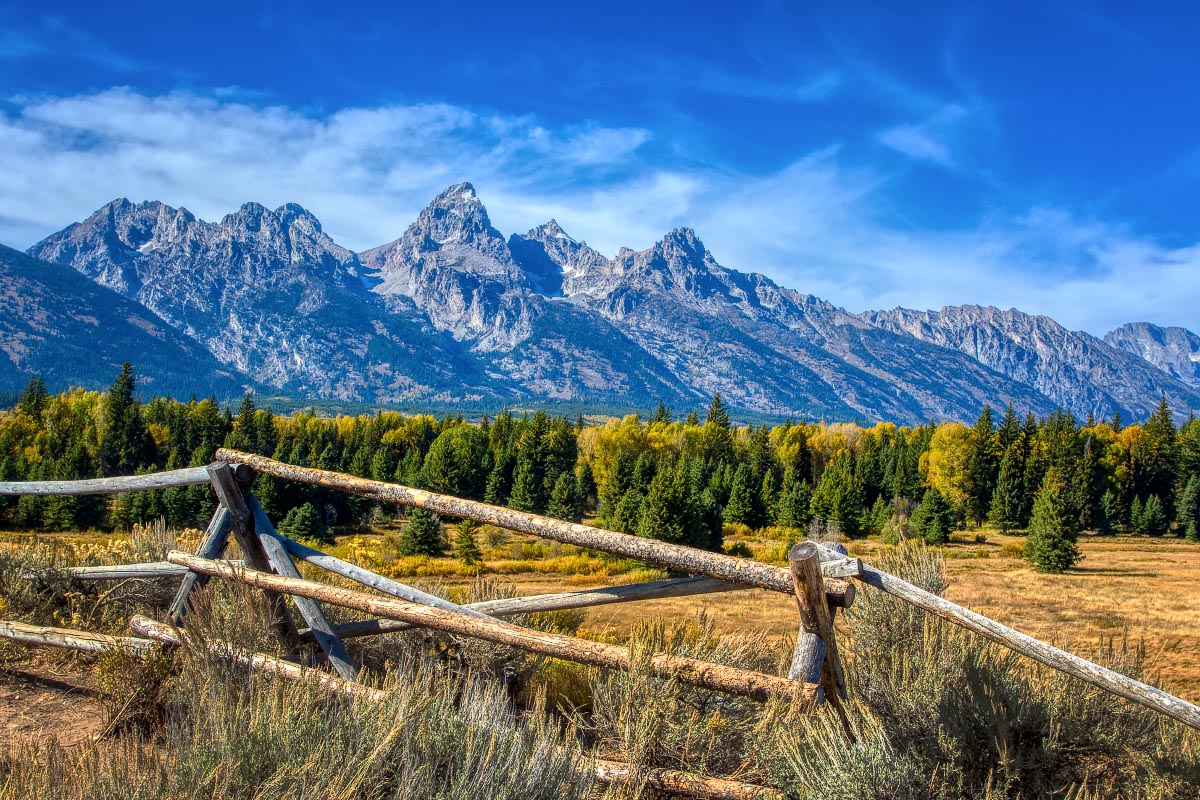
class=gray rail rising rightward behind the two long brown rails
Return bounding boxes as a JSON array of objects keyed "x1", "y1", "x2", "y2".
[{"x1": 300, "y1": 577, "x2": 749, "y2": 640}]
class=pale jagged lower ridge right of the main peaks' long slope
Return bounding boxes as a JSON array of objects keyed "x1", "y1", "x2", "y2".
[{"x1": 863, "y1": 306, "x2": 1200, "y2": 420}]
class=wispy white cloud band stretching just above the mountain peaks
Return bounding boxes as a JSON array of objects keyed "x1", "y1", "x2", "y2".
[{"x1": 0, "y1": 89, "x2": 1200, "y2": 333}]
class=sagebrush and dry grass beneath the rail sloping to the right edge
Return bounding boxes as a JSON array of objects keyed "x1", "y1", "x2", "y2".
[{"x1": 764, "y1": 543, "x2": 1200, "y2": 800}]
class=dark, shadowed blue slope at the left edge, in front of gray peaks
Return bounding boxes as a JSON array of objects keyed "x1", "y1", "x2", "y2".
[{"x1": 0, "y1": 245, "x2": 246, "y2": 398}]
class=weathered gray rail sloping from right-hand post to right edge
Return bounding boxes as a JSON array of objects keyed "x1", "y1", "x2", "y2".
[{"x1": 820, "y1": 546, "x2": 1200, "y2": 730}]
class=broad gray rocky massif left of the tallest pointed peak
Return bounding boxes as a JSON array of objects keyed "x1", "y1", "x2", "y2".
[{"x1": 30, "y1": 199, "x2": 503, "y2": 402}]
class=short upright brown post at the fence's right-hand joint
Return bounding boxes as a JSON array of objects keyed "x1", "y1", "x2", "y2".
[{"x1": 787, "y1": 542, "x2": 846, "y2": 706}]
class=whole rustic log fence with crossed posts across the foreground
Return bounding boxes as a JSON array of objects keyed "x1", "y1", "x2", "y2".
[{"x1": 0, "y1": 450, "x2": 1200, "y2": 798}]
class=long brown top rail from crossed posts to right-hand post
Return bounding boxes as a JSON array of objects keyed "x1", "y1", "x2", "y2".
[{"x1": 217, "y1": 447, "x2": 854, "y2": 607}]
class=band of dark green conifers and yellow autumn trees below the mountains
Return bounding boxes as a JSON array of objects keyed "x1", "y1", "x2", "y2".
[{"x1": 0, "y1": 365, "x2": 1200, "y2": 566}]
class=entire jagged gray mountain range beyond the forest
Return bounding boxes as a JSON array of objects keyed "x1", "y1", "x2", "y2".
[{"x1": 9, "y1": 184, "x2": 1200, "y2": 423}]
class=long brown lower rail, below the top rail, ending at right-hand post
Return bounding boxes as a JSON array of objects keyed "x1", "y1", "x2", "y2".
[{"x1": 167, "y1": 551, "x2": 816, "y2": 702}]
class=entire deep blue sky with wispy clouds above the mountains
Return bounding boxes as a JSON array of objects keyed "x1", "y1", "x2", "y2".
[{"x1": 0, "y1": 0, "x2": 1200, "y2": 333}]
